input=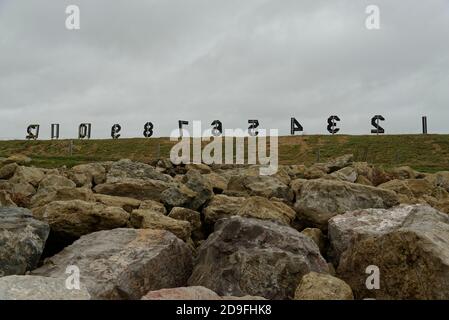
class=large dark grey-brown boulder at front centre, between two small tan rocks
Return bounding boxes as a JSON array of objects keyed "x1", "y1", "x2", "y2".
[{"x1": 189, "y1": 217, "x2": 328, "y2": 299}]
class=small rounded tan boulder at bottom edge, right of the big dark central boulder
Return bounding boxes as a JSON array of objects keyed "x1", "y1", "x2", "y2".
[{"x1": 295, "y1": 272, "x2": 354, "y2": 300}]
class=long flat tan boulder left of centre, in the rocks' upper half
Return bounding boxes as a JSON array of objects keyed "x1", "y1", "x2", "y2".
[{"x1": 94, "y1": 179, "x2": 169, "y2": 201}]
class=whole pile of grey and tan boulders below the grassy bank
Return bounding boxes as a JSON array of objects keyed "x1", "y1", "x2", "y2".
[{"x1": 0, "y1": 155, "x2": 449, "y2": 300}]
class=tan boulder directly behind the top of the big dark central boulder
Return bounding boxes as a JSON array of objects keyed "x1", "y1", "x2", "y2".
[{"x1": 237, "y1": 197, "x2": 296, "y2": 225}]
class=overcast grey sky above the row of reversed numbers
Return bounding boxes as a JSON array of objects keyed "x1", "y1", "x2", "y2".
[{"x1": 0, "y1": 0, "x2": 449, "y2": 139}]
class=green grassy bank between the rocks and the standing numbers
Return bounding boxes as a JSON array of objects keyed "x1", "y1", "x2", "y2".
[{"x1": 0, "y1": 135, "x2": 449, "y2": 172}]
